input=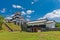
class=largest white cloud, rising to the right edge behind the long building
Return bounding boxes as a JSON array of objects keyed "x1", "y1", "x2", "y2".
[{"x1": 38, "y1": 9, "x2": 60, "y2": 21}]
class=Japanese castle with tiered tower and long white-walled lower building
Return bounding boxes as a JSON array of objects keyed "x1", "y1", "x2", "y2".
[{"x1": 6, "y1": 12, "x2": 55, "y2": 32}]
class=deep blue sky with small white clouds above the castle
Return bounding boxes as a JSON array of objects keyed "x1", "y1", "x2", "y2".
[{"x1": 0, "y1": 0, "x2": 60, "y2": 20}]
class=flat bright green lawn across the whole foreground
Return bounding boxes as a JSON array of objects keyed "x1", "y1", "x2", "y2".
[{"x1": 0, "y1": 31, "x2": 60, "y2": 40}]
